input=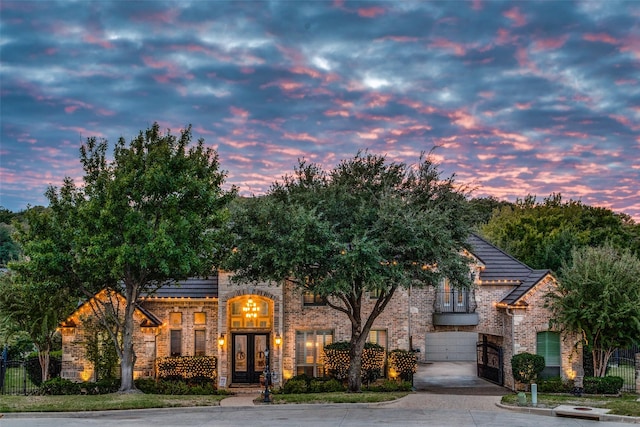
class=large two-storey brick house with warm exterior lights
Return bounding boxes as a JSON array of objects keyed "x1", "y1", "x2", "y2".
[{"x1": 61, "y1": 235, "x2": 581, "y2": 388}]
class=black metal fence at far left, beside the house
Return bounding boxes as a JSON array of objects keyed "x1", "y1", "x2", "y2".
[{"x1": 0, "y1": 358, "x2": 61, "y2": 396}]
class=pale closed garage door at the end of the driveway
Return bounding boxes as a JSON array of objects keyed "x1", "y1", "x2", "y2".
[{"x1": 426, "y1": 332, "x2": 478, "y2": 362}]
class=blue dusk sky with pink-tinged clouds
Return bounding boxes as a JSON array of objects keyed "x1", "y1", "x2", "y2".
[{"x1": 0, "y1": 0, "x2": 640, "y2": 222}]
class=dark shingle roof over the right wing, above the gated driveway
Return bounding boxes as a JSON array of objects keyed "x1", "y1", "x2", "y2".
[{"x1": 468, "y1": 234, "x2": 549, "y2": 305}]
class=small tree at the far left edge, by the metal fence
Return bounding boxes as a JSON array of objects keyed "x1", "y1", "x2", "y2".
[{"x1": 0, "y1": 271, "x2": 75, "y2": 381}]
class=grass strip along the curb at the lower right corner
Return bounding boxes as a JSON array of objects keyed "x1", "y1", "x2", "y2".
[{"x1": 502, "y1": 393, "x2": 640, "y2": 417}]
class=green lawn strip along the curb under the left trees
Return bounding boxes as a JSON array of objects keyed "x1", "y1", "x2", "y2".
[{"x1": 0, "y1": 393, "x2": 228, "y2": 413}]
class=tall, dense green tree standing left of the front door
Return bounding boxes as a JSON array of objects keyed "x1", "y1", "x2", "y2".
[{"x1": 17, "y1": 123, "x2": 235, "y2": 392}]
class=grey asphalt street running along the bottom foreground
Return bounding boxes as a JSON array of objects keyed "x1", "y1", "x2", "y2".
[{"x1": 0, "y1": 404, "x2": 630, "y2": 427}]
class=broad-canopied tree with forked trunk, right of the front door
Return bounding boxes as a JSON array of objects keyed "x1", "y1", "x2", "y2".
[{"x1": 226, "y1": 153, "x2": 470, "y2": 392}]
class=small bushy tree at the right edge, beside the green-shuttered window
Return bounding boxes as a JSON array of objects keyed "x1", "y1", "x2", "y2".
[{"x1": 548, "y1": 244, "x2": 640, "y2": 377}]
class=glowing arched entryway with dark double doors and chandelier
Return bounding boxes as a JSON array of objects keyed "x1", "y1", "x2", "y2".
[{"x1": 227, "y1": 295, "x2": 273, "y2": 384}]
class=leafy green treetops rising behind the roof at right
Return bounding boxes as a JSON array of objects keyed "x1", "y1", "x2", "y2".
[{"x1": 481, "y1": 194, "x2": 640, "y2": 271}]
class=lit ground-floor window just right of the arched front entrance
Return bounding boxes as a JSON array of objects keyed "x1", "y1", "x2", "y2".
[{"x1": 296, "y1": 331, "x2": 333, "y2": 377}]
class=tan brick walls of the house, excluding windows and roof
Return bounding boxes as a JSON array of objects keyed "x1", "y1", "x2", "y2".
[{"x1": 62, "y1": 237, "x2": 581, "y2": 388}]
